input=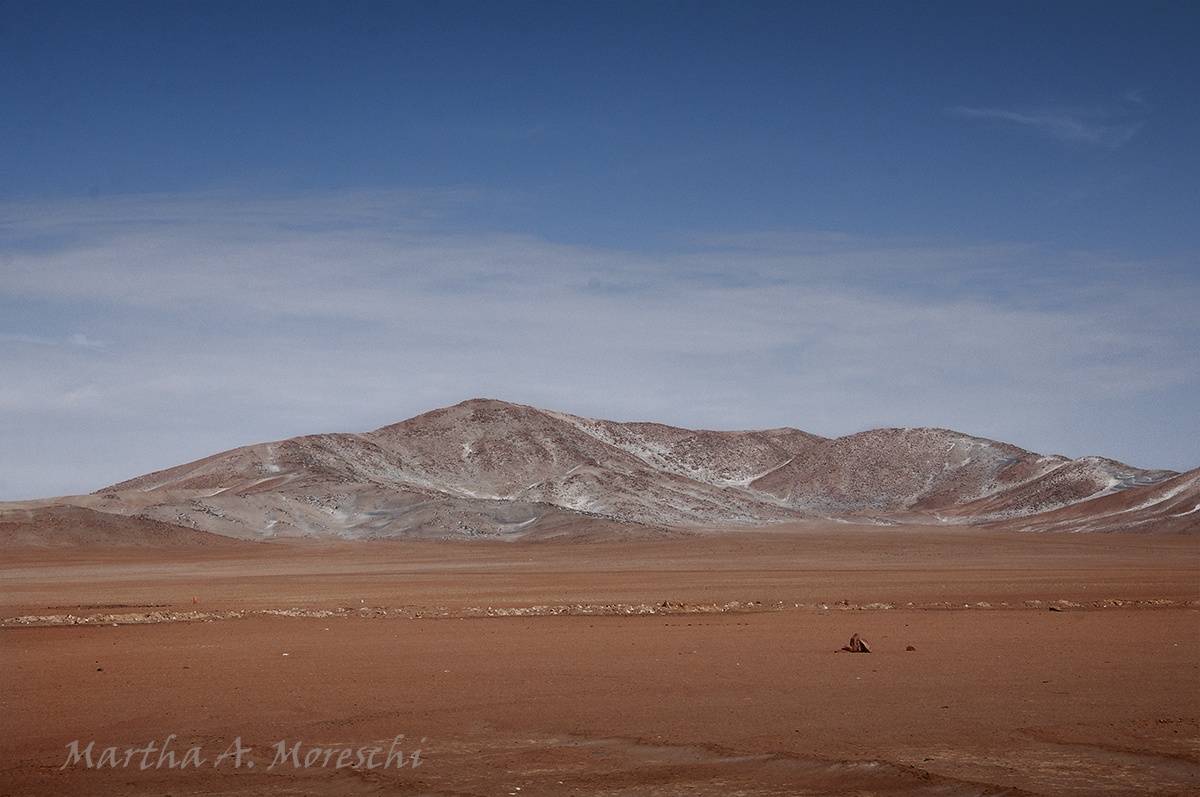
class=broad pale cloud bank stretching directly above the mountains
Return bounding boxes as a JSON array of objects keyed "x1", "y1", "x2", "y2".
[{"x1": 0, "y1": 193, "x2": 1200, "y2": 497}]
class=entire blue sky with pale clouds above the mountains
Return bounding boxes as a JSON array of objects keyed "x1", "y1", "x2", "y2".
[{"x1": 0, "y1": 0, "x2": 1200, "y2": 499}]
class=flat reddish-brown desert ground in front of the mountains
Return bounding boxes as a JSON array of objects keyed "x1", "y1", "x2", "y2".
[{"x1": 0, "y1": 527, "x2": 1200, "y2": 796}]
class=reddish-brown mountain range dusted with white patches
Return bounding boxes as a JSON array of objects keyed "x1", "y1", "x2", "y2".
[{"x1": 9, "y1": 399, "x2": 1200, "y2": 539}]
